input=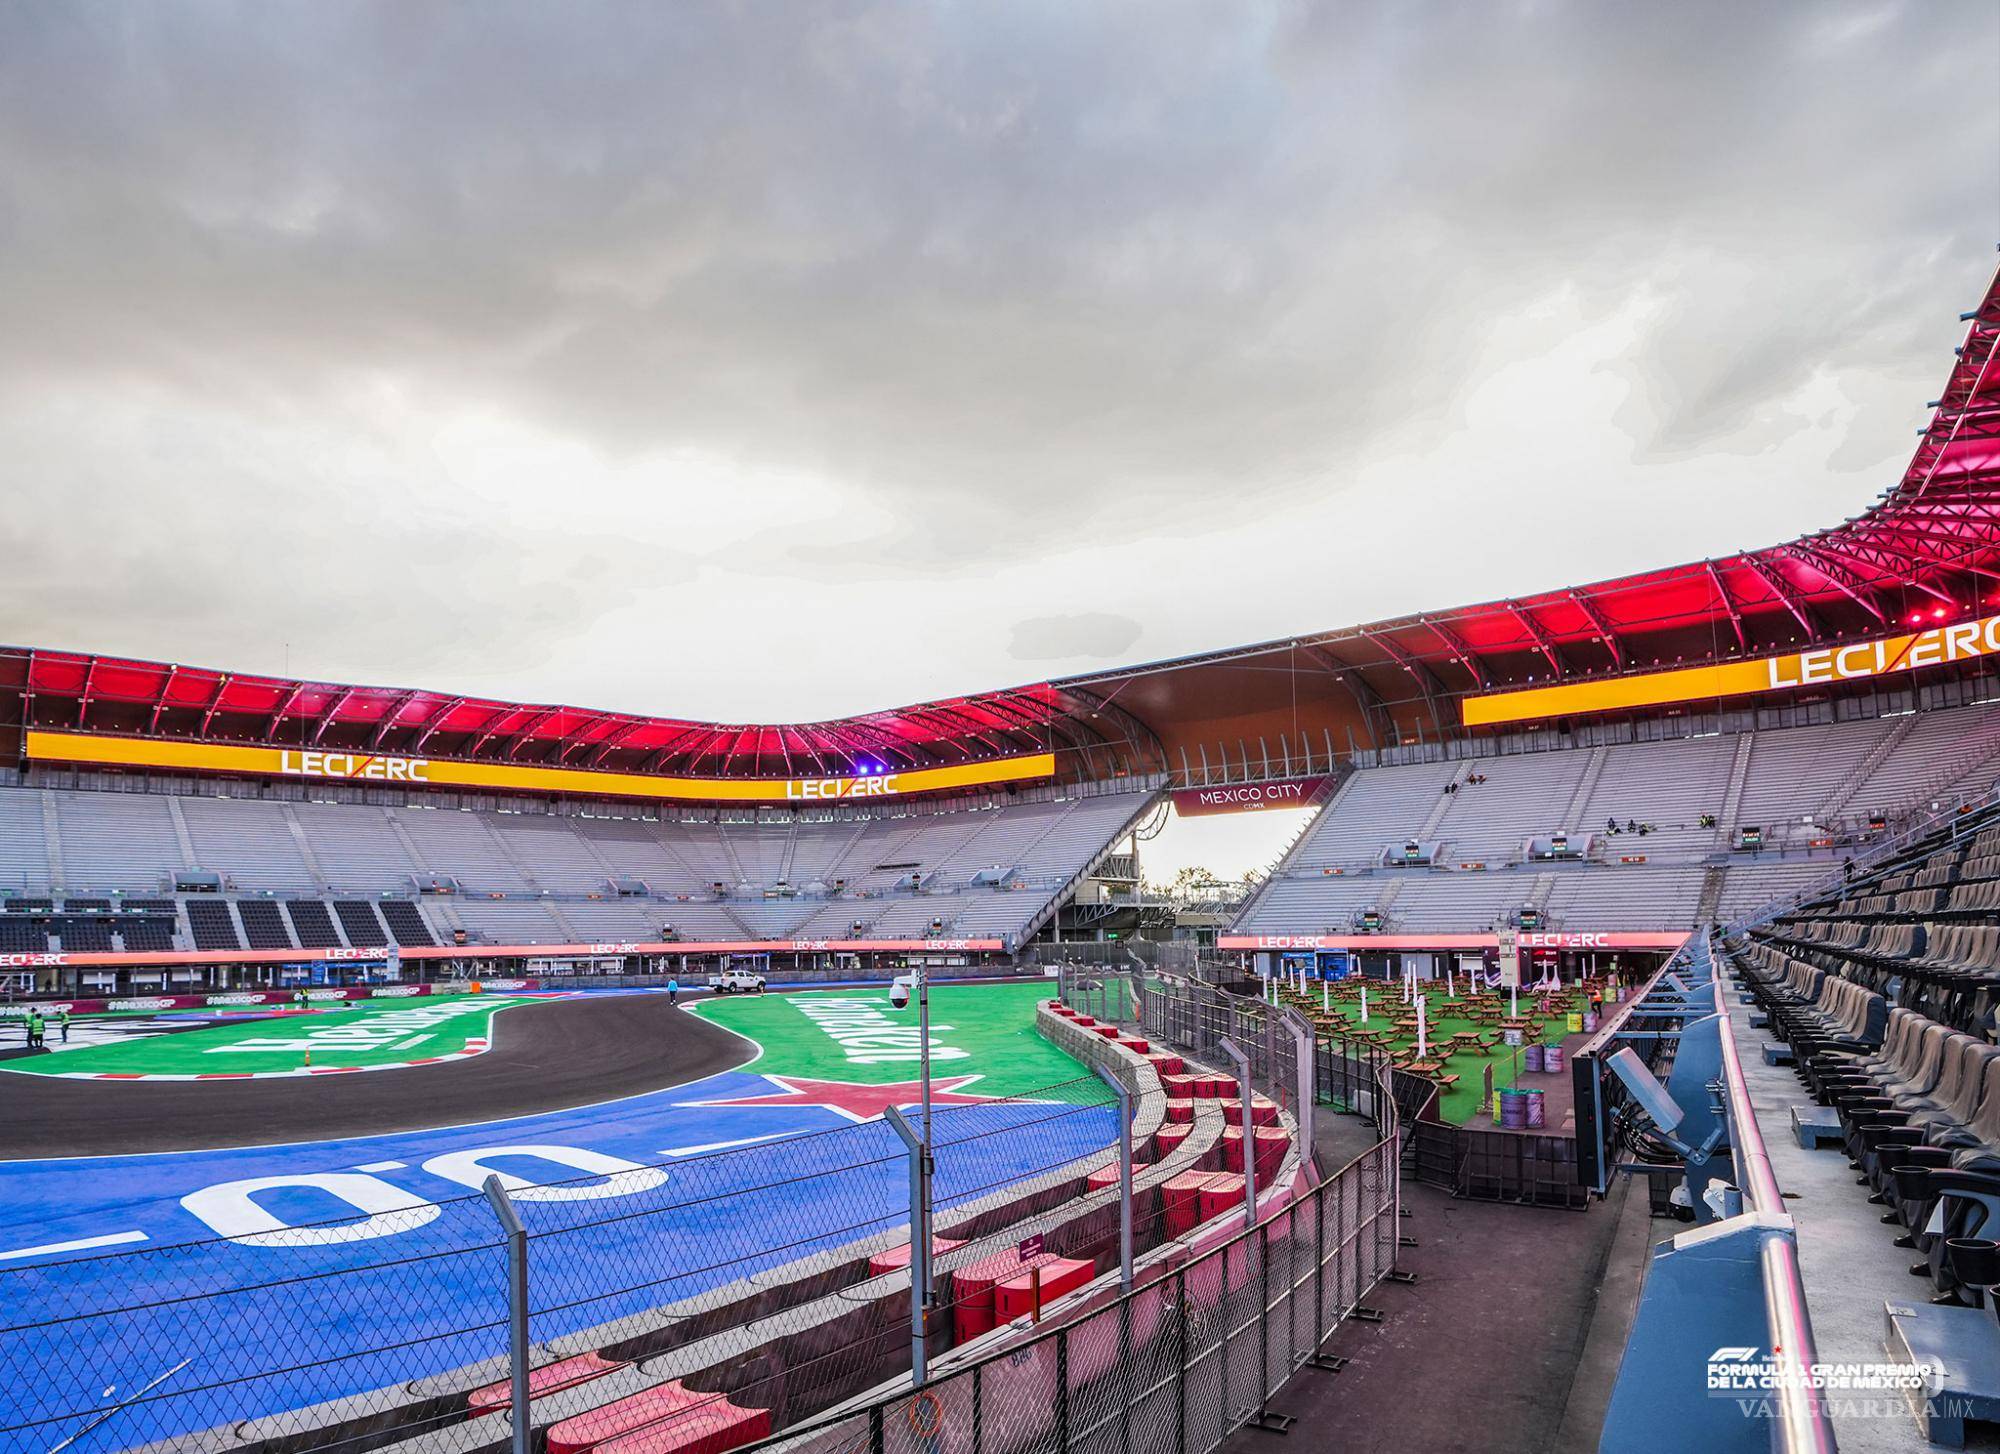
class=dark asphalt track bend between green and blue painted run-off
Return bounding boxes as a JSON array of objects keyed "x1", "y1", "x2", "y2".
[{"x1": 0, "y1": 994, "x2": 756, "y2": 1162}]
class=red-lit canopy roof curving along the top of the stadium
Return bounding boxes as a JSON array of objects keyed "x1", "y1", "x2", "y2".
[{"x1": 0, "y1": 262, "x2": 2000, "y2": 776}]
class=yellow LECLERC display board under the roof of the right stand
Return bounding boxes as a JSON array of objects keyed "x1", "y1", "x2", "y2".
[{"x1": 1462, "y1": 616, "x2": 2000, "y2": 726}]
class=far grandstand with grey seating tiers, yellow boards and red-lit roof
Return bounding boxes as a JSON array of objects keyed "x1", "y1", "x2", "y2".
[{"x1": 0, "y1": 262, "x2": 2000, "y2": 986}]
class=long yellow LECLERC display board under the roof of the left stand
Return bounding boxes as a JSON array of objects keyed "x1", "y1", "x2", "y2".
[{"x1": 28, "y1": 728, "x2": 1056, "y2": 804}]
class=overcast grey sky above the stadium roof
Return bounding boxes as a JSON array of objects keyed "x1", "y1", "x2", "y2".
[{"x1": 0, "y1": 0, "x2": 2000, "y2": 720}]
